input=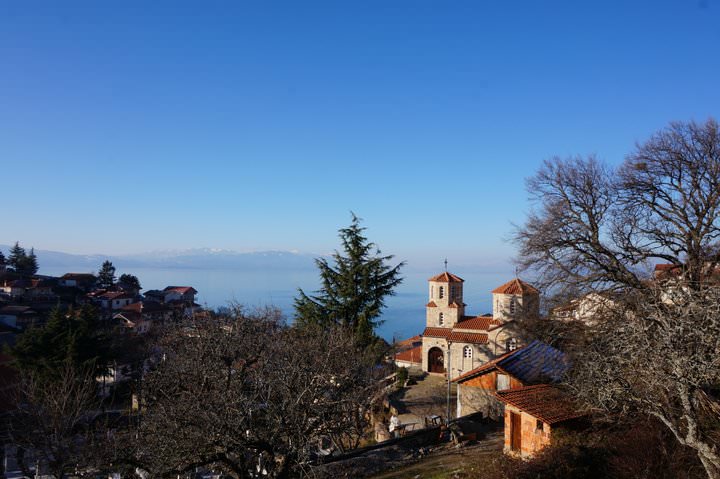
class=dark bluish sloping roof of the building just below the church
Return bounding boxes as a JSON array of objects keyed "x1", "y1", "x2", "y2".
[{"x1": 455, "y1": 340, "x2": 569, "y2": 384}]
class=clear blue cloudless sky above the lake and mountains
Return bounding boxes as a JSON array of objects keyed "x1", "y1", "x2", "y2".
[{"x1": 0, "y1": 0, "x2": 720, "y2": 267}]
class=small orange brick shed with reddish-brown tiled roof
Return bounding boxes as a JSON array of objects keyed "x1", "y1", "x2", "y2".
[{"x1": 495, "y1": 384, "x2": 584, "y2": 457}]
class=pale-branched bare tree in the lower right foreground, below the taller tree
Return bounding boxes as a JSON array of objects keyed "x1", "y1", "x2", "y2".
[{"x1": 570, "y1": 286, "x2": 720, "y2": 478}]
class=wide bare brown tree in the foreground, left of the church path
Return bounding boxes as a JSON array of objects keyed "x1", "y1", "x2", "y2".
[{"x1": 135, "y1": 308, "x2": 376, "y2": 478}]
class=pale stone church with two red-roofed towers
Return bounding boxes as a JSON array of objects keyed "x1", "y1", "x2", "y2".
[{"x1": 416, "y1": 271, "x2": 540, "y2": 379}]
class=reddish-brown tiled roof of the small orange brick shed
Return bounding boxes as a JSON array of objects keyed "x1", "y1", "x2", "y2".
[{"x1": 495, "y1": 384, "x2": 584, "y2": 425}]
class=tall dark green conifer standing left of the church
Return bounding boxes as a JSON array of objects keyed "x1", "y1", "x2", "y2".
[{"x1": 295, "y1": 214, "x2": 404, "y2": 347}]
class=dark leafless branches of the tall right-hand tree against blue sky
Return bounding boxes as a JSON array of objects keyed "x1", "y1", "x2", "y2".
[{"x1": 515, "y1": 119, "x2": 720, "y2": 293}]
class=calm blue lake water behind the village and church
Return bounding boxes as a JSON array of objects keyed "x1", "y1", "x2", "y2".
[{"x1": 40, "y1": 267, "x2": 513, "y2": 341}]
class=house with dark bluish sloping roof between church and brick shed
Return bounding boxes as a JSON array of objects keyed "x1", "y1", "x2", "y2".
[{"x1": 453, "y1": 340, "x2": 568, "y2": 417}]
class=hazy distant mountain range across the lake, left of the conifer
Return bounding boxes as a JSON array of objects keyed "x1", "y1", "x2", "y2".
[{"x1": 0, "y1": 245, "x2": 317, "y2": 273}]
